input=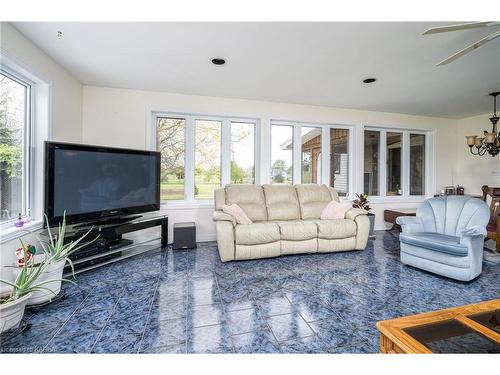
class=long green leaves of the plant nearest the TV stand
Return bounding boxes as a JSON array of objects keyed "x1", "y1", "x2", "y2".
[{"x1": 38, "y1": 211, "x2": 99, "y2": 275}]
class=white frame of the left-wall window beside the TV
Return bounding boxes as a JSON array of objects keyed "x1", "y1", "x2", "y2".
[{"x1": 0, "y1": 49, "x2": 52, "y2": 243}]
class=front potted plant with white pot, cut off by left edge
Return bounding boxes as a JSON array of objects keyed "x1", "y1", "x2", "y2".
[{"x1": 0, "y1": 248, "x2": 55, "y2": 333}]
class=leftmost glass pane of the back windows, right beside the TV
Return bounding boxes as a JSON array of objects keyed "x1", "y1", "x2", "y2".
[{"x1": 156, "y1": 117, "x2": 186, "y2": 200}]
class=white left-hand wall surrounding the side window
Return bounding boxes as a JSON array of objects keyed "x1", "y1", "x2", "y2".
[{"x1": 0, "y1": 22, "x2": 82, "y2": 277}]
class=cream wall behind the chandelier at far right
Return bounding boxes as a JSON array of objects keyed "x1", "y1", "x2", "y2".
[{"x1": 453, "y1": 113, "x2": 500, "y2": 194}]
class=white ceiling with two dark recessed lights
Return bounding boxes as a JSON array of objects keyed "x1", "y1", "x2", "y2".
[{"x1": 10, "y1": 22, "x2": 500, "y2": 118}]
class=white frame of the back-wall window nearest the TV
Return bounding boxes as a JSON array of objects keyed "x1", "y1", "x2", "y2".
[{"x1": 146, "y1": 109, "x2": 260, "y2": 209}]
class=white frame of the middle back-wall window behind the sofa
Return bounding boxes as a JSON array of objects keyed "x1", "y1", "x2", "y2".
[{"x1": 267, "y1": 119, "x2": 357, "y2": 200}]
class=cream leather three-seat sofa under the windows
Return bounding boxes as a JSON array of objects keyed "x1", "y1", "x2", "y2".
[{"x1": 213, "y1": 184, "x2": 370, "y2": 262}]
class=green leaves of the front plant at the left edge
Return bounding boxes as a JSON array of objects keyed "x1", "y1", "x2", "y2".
[{"x1": 0, "y1": 244, "x2": 73, "y2": 304}]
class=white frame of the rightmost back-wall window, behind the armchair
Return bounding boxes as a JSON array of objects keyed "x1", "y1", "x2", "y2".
[{"x1": 360, "y1": 125, "x2": 436, "y2": 203}]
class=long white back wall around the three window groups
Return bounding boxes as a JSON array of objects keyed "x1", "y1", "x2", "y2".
[{"x1": 83, "y1": 86, "x2": 456, "y2": 240}]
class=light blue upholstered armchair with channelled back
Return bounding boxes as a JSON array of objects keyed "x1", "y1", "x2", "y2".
[{"x1": 396, "y1": 195, "x2": 490, "y2": 281}]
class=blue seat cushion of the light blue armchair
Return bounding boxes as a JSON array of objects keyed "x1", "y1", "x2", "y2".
[{"x1": 399, "y1": 232, "x2": 468, "y2": 257}]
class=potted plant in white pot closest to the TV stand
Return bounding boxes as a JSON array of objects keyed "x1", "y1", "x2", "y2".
[{"x1": 21, "y1": 211, "x2": 97, "y2": 306}]
